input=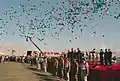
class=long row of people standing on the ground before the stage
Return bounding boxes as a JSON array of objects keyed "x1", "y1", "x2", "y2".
[{"x1": 23, "y1": 54, "x2": 89, "y2": 81}]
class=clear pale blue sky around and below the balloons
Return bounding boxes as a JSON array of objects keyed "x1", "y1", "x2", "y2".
[{"x1": 0, "y1": 0, "x2": 120, "y2": 51}]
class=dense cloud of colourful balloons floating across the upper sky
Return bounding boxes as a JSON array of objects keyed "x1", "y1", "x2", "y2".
[{"x1": 0, "y1": 0, "x2": 120, "y2": 42}]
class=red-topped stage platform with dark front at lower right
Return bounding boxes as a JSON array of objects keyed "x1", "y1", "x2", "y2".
[{"x1": 88, "y1": 64, "x2": 120, "y2": 81}]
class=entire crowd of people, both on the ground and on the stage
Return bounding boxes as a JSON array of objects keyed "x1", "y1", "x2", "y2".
[{"x1": 0, "y1": 48, "x2": 112, "y2": 81}]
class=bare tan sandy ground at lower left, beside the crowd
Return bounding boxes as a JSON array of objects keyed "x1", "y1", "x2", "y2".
[{"x1": 0, "y1": 62, "x2": 56, "y2": 81}]
